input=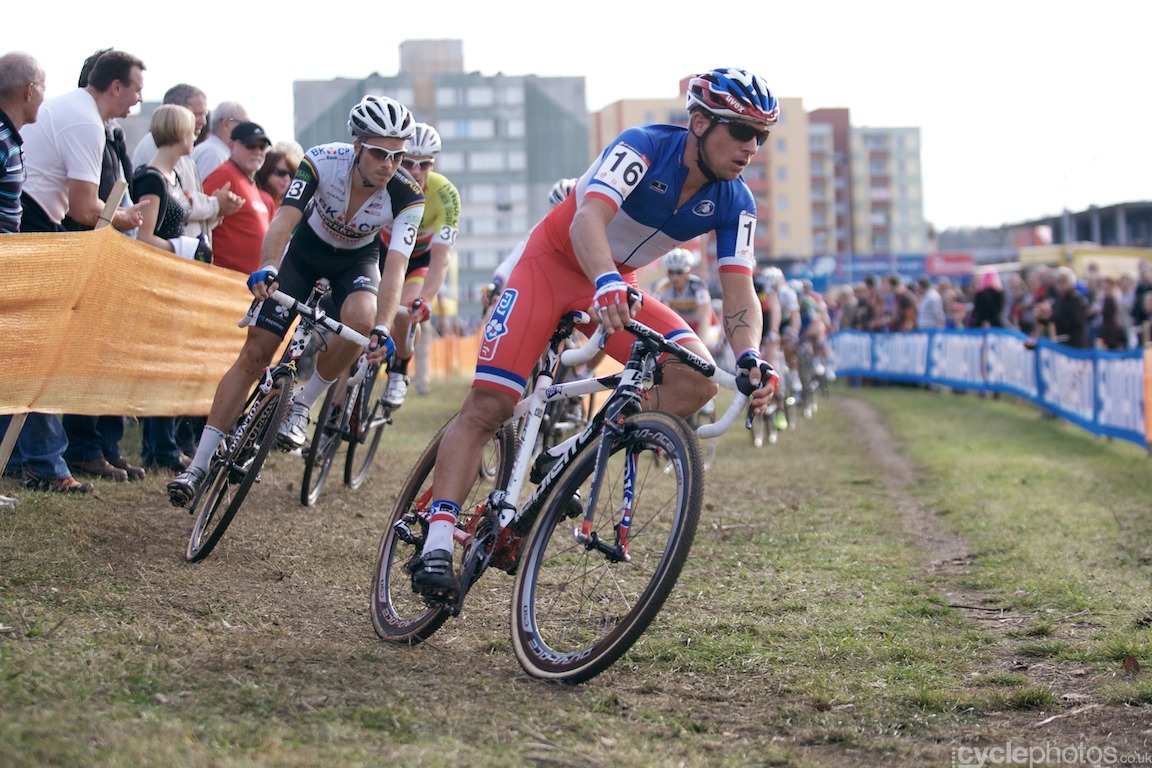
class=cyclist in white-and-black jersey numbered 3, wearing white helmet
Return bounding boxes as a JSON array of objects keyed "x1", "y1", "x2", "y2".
[{"x1": 168, "y1": 96, "x2": 424, "y2": 505}]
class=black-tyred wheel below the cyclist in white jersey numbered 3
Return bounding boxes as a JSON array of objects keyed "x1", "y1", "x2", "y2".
[{"x1": 184, "y1": 371, "x2": 293, "y2": 562}]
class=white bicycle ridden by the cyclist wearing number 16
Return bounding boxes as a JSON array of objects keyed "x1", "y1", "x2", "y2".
[{"x1": 371, "y1": 312, "x2": 751, "y2": 683}]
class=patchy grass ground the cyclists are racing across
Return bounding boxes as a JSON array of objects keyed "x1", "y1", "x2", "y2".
[{"x1": 0, "y1": 382, "x2": 1152, "y2": 767}]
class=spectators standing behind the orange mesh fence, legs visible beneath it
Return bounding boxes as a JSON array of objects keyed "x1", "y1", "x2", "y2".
[{"x1": 0, "y1": 48, "x2": 304, "y2": 495}]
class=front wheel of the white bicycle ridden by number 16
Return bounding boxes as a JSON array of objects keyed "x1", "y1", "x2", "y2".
[{"x1": 511, "y1": 411, "x2": 704, "y2": 683}]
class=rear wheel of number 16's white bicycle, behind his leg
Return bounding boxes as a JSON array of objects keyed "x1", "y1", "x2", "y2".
[{"x1": 372, "y1": 421, "x2": 515, "y2": 642}]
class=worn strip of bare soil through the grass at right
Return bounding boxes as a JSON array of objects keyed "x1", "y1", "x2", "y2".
[{"x1": 838, "y1": 397, "x2": 1152, "y2": 766}]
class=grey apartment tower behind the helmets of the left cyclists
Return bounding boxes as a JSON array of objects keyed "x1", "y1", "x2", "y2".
[{"x1": 294, "y1": 40, "x2": 590, "y2": 321}]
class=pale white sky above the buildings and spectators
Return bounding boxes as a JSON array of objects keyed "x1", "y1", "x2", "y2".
[{"x1": 9, "y1": 0, "x2": 1152, "y2": 229}]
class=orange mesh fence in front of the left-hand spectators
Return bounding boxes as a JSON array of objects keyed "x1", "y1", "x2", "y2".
[{"x1": 0, "y1": 228, "x2": 478, "y2": 416}]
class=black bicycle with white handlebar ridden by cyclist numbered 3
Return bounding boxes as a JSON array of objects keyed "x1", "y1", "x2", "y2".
[{"x1": 174, "y1": 279, "x2": 369, "y2": 562}]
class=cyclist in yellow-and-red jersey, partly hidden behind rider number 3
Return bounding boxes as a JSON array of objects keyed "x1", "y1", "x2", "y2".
[{"x1": 381, "y1": 123, "x2": 460, "y2": 409}]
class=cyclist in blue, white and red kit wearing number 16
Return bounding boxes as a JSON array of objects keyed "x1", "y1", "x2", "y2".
[{"x1": 411, "y1": 69, "x2": 779, "y2": 598}]
